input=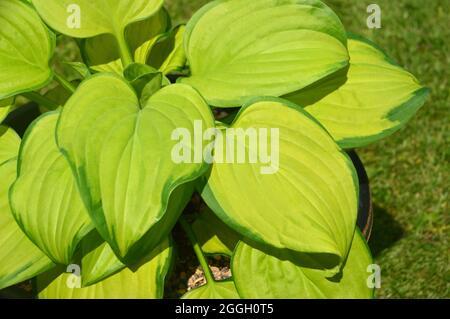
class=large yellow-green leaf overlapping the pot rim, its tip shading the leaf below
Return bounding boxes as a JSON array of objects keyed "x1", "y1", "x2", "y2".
[{"x1": 202, "y1": 98, "x2": 358, "y2": 273}]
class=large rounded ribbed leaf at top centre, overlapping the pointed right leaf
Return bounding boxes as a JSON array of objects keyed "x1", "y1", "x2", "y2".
[{"x1": 181, "y1": 0, "x2": 348, "y2": 107}]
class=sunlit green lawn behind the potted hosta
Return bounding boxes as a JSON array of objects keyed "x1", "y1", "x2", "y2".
[{"x1": 166, "y1": 0, "x2": 450, "y2": 298}]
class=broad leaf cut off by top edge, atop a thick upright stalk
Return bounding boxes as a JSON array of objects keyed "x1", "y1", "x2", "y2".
[{"x1": 32, "y1": 0, "x2": 163, "y2": 38}]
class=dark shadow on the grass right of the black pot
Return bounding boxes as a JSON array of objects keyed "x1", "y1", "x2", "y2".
[{"x1": 369, "y1": 204, "x2": 405, "y2": 257}]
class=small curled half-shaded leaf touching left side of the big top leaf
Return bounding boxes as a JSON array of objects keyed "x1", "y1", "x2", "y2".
[{"x1": 147, "y1": 25, "x2": 186, "y2": 74}]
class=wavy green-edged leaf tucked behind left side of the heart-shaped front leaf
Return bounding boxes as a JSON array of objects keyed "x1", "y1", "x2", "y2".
[{"x1": 10, "y1": 112, "x2": 93, "y2": 265}]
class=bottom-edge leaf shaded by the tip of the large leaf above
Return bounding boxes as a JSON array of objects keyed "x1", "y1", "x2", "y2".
[{"x1": 232, "y1": 231, "x2": 374, "y2": 299}]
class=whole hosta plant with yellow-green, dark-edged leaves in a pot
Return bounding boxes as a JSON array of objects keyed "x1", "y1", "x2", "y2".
[{"x1": 0, "y1": 0, "x2": 428, "y2": 298}]
